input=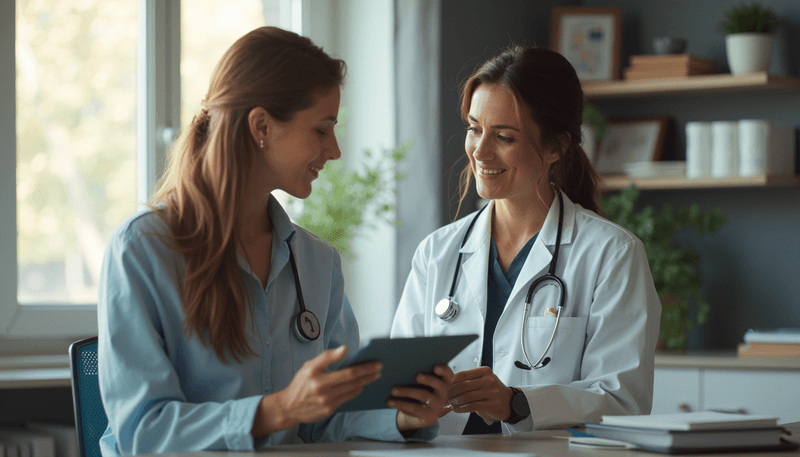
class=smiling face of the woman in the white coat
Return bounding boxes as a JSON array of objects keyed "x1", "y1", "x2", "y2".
[{"x1": 464, "y1": 84, "x2": 558, "y2": 202}]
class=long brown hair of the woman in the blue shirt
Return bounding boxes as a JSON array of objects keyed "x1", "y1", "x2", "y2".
[{"x1": 149, "y1": 27, "x2": 345, "y2": 362}]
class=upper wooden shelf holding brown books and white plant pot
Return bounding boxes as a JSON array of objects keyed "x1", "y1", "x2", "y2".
[{"x1": 583, "y1": 72, "x2": 800, "y2": 100}]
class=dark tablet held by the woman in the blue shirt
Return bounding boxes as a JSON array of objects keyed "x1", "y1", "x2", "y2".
[{"x1": 336, "y1": 335, "x2": 478, "y2": 413}]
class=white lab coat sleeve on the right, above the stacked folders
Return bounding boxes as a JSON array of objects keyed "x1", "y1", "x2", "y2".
[{"x1": 504, "y1": 239, "x2": 661, "y2": 432}]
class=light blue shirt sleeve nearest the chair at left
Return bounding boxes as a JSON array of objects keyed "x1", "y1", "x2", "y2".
[{"x1": 98, "y1": 228, "x2": 261, "y2": 455}]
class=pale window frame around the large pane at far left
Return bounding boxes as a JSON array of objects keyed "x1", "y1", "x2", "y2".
[{"x1": 0, "y1": 0, "x2": 181, "y2": 342}]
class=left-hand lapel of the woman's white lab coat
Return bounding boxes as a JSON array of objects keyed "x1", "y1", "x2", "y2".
[{"x1": 456, "y1": 202, "x2": 494, "y2": 319}]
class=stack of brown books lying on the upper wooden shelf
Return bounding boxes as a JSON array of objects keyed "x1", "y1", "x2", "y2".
[{"x1": 625, "y1": 54, "x2": 716, "y2": 81}]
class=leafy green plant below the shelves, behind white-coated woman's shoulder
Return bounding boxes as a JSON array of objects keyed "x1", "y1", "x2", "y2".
[{"x1": 600, "y1": 185, "x2": 728, "y2": 350}]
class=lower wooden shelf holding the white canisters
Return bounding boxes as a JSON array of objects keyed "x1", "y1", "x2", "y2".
[{"x1": 602, "y1": 175, "x2": 800, "y2": 191}]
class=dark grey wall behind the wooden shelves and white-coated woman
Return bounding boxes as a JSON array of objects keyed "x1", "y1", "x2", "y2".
[{"x1": 440, "y1": 0, "x2": 800, "y2": 350}]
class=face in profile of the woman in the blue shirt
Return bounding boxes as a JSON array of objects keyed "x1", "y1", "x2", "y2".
[{"x1": 250, "y1": 87, "x2": 342, "y2": 198}]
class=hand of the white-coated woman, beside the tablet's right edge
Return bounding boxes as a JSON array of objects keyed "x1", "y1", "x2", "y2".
[{"x1": 450, "y1": 367, "x2": 513, "y2": 421}]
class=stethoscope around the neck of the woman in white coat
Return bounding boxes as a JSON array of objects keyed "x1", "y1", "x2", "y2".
[{"x1": 434, "y1": 192, "x2": 567, "y2": 370}]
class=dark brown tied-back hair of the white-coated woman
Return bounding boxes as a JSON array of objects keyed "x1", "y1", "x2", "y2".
[{"x1": 456, "y1": 46, "x2": 600, "y2": 216}]
